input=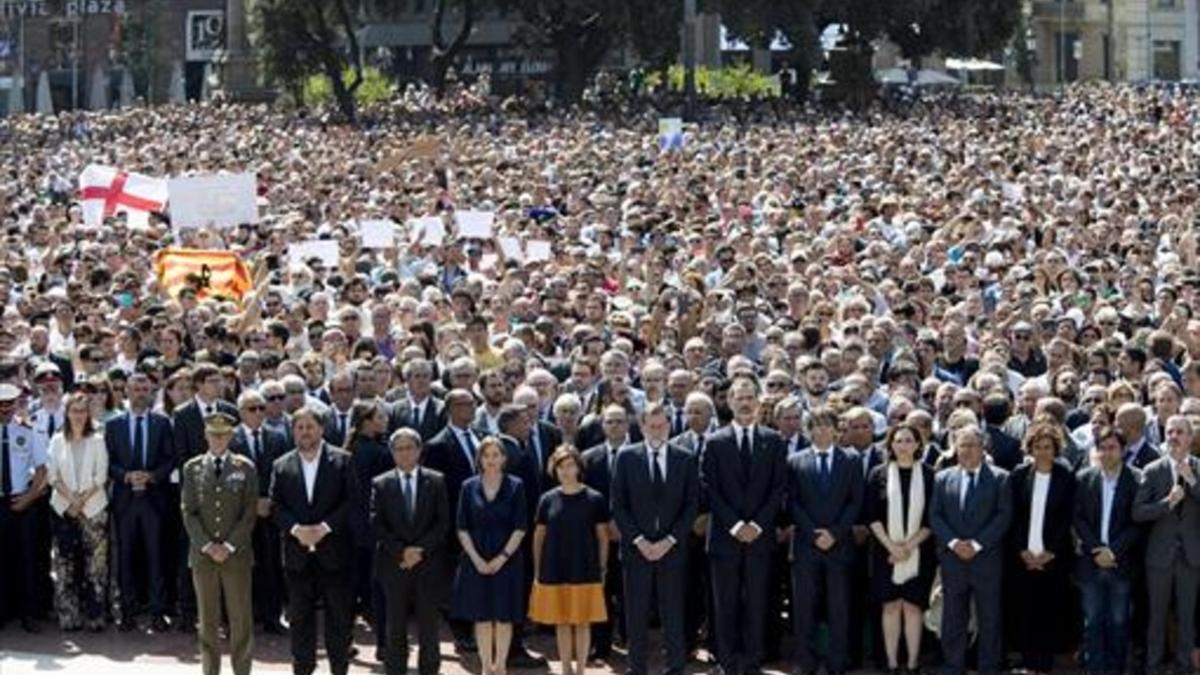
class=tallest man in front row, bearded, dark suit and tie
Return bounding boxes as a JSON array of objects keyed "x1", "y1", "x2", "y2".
[{"x1": 701, "y1": 376, "x2": 787, "y2": 675}]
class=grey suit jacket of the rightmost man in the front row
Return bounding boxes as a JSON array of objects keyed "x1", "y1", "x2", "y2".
[{"x1": 1133, "y1": 455, "x2": 1200, "y2": 569}]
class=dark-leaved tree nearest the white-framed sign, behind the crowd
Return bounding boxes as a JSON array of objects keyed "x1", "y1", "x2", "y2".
[{"x1": 251, "y1": 0, "x2": 362, "y2": 123}]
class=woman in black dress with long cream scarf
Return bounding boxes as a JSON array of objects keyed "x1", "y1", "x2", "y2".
[{"x1": 865, "y1": 423, "x2": 936, "y2": 673}]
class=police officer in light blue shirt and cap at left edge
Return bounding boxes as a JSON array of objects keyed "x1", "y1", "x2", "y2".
[{"x1": 0, "y1": 384, "x2": 48, "y2": 633}]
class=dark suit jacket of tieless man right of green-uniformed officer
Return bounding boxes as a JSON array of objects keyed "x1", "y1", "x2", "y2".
[{"x1": 270, "y1": 443, "x2": 359, "y2": 571}]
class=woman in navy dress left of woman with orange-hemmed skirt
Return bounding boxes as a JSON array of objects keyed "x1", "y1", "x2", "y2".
[{"x1": 450, "y1": 436, "x2": 528, "y2": 675}]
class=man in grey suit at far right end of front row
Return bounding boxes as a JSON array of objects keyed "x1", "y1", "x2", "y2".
[{"x1": 1133, "y1": 414, "x2": 1200, "y2": 673}]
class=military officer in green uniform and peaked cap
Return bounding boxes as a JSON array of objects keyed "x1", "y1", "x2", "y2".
[{"x1": 182, "y1": 412, "x2": 258, "y2": 675}]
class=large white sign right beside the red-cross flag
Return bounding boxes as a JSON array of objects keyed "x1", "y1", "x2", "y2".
[{"x1": 167, "y1": 173, "x2": 258, "y2": 228}]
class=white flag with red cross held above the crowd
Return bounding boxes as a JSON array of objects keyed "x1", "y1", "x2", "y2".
[{"x1": 79, "y1": 165, "x2": 167, "y2": 226}]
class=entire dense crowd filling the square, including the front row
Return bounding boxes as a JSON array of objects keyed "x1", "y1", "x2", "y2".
[{"x1": 0, "y1": 81, "x2": 1200, "y2": 675}]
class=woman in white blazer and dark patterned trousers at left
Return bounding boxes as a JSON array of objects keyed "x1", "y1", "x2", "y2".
[{"x1": 47, "y1": 393, "x2": 108, "y2": 633}]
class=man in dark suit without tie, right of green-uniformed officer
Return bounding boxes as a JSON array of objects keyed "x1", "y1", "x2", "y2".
[{"x1": 270, "y1": 407, "x2": 359, "y2": 675}]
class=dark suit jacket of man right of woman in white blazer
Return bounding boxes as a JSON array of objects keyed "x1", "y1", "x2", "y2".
[{"x1": 104, "y1": 411, "x2": 178, "y2": 509}]
